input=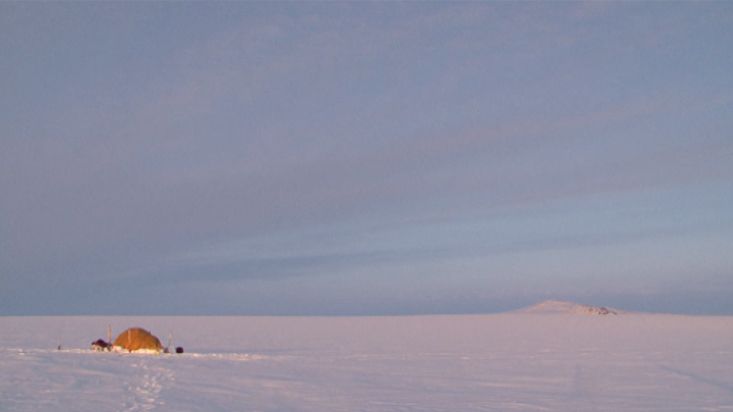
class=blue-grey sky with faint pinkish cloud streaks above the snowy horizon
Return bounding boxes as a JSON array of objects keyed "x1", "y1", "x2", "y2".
[{"x1": 0, "y1": 2, "x2": 733, "y2": 315}]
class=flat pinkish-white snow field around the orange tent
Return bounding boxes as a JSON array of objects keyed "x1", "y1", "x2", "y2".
[{"x1": 0, "y1": 313, "x2": 733, "y2": 412}]
